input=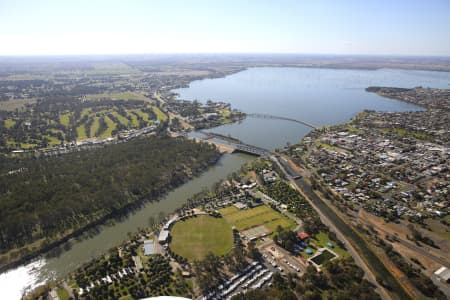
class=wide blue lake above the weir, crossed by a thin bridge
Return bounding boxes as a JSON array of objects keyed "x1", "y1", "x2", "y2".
[{"x1": 174, "y1": 68, "x2": 450, "y2": 150}]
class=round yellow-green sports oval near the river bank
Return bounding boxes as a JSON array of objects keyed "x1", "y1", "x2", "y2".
[{"x1": 170, "y1": 216, "x2": 233, "y2": 261}]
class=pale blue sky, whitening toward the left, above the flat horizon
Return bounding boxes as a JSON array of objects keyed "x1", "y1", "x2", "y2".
[{"x1": 0, "y1": 0, "x2": 450, "y2": 56}]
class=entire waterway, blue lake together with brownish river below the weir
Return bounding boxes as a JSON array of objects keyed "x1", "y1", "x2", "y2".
[{"x1": 0, "y1": 68, "x2": 450, "y2": 299}]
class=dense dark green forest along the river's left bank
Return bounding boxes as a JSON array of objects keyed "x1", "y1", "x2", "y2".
[{"x1": 0, "y1": 136, "x2": 218, "y2": 252}]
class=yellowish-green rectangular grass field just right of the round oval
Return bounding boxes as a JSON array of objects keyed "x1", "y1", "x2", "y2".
[{"x1": 220, "y1": 205, "x2": 296, "y2": 231}]
